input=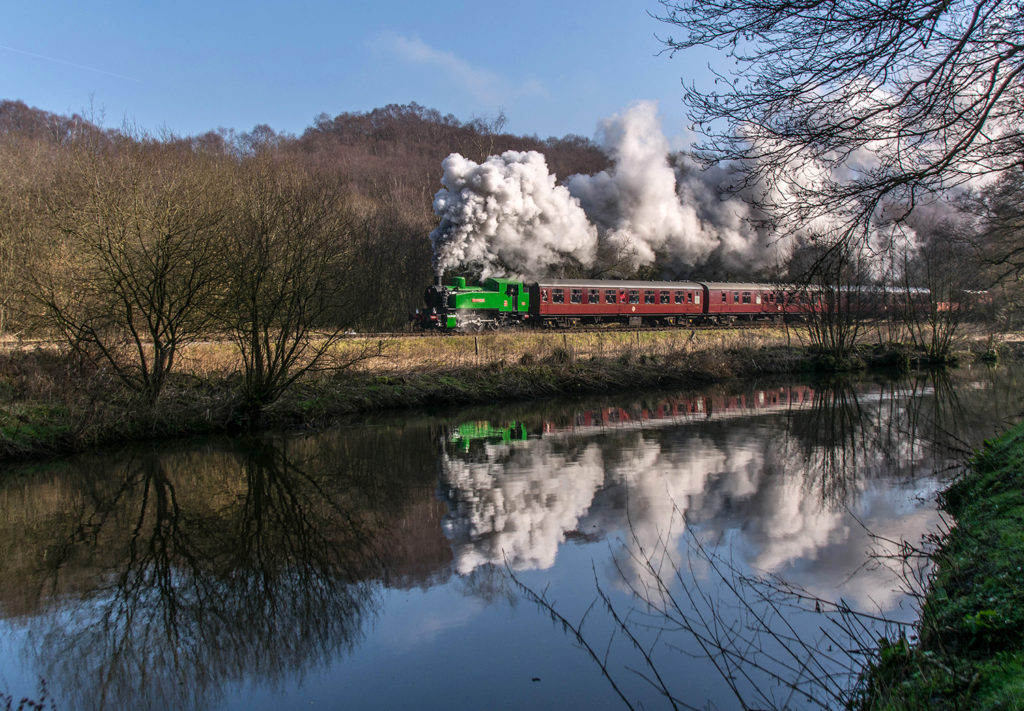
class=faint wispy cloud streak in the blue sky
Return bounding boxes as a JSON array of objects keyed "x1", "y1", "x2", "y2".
[{"x1": 375, "y1": 32, "x2": 548, "y2": 106}]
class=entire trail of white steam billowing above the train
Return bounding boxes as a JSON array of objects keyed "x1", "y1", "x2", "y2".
[{"x1": 430, "y1": 101, "x2": 974, "y2": 279}]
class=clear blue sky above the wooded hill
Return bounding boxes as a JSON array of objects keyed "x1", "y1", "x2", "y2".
[{"x1": 0, "y1": 0, "x2": 715, "y2": 144}]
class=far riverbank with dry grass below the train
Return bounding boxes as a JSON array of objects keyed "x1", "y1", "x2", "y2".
[{"x1": 0, "y1": 330, "x2": 1015, "y2": 460}]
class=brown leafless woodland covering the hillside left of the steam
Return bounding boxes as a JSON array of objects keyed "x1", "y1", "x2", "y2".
[{"x1": 0, "y1": 100, "x2": 608, "y2": 335}]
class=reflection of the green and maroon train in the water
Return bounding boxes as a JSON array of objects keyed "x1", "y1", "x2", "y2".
[{"x1": 449, "y1": 385, "x2": 814, "y2": 453}]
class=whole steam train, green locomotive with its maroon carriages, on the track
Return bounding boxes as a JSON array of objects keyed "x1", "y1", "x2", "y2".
[{"x1": 414, "y1": 277, "x2": 930, "y2": 331}]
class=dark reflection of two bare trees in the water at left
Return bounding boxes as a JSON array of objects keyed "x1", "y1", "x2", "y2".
[{"x1": 24, "y1": 442, "x2": 385, "y2": 708}]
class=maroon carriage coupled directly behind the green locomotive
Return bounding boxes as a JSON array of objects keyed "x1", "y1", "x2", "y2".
[{"x1": 529, "y1": 279, "x2": 707, "y2": 326}]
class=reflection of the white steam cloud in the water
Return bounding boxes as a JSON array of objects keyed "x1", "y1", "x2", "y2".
[{"x1": 442, "y1": 379, "x2": 966, "y2": 605}]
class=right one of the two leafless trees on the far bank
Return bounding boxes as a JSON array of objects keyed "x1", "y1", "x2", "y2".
[{"x1": 221, "y1": 156, "x2": 381, "y2": 421}]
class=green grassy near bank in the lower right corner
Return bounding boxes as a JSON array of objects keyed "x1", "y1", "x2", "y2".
[{"x1": 857, "y1": 423, "x2": 1024, "y2": 711}]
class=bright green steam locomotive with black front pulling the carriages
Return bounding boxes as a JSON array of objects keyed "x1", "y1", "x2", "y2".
[{"x1": 414, "y1": 277, "x2": 530, "y2": 331}]
